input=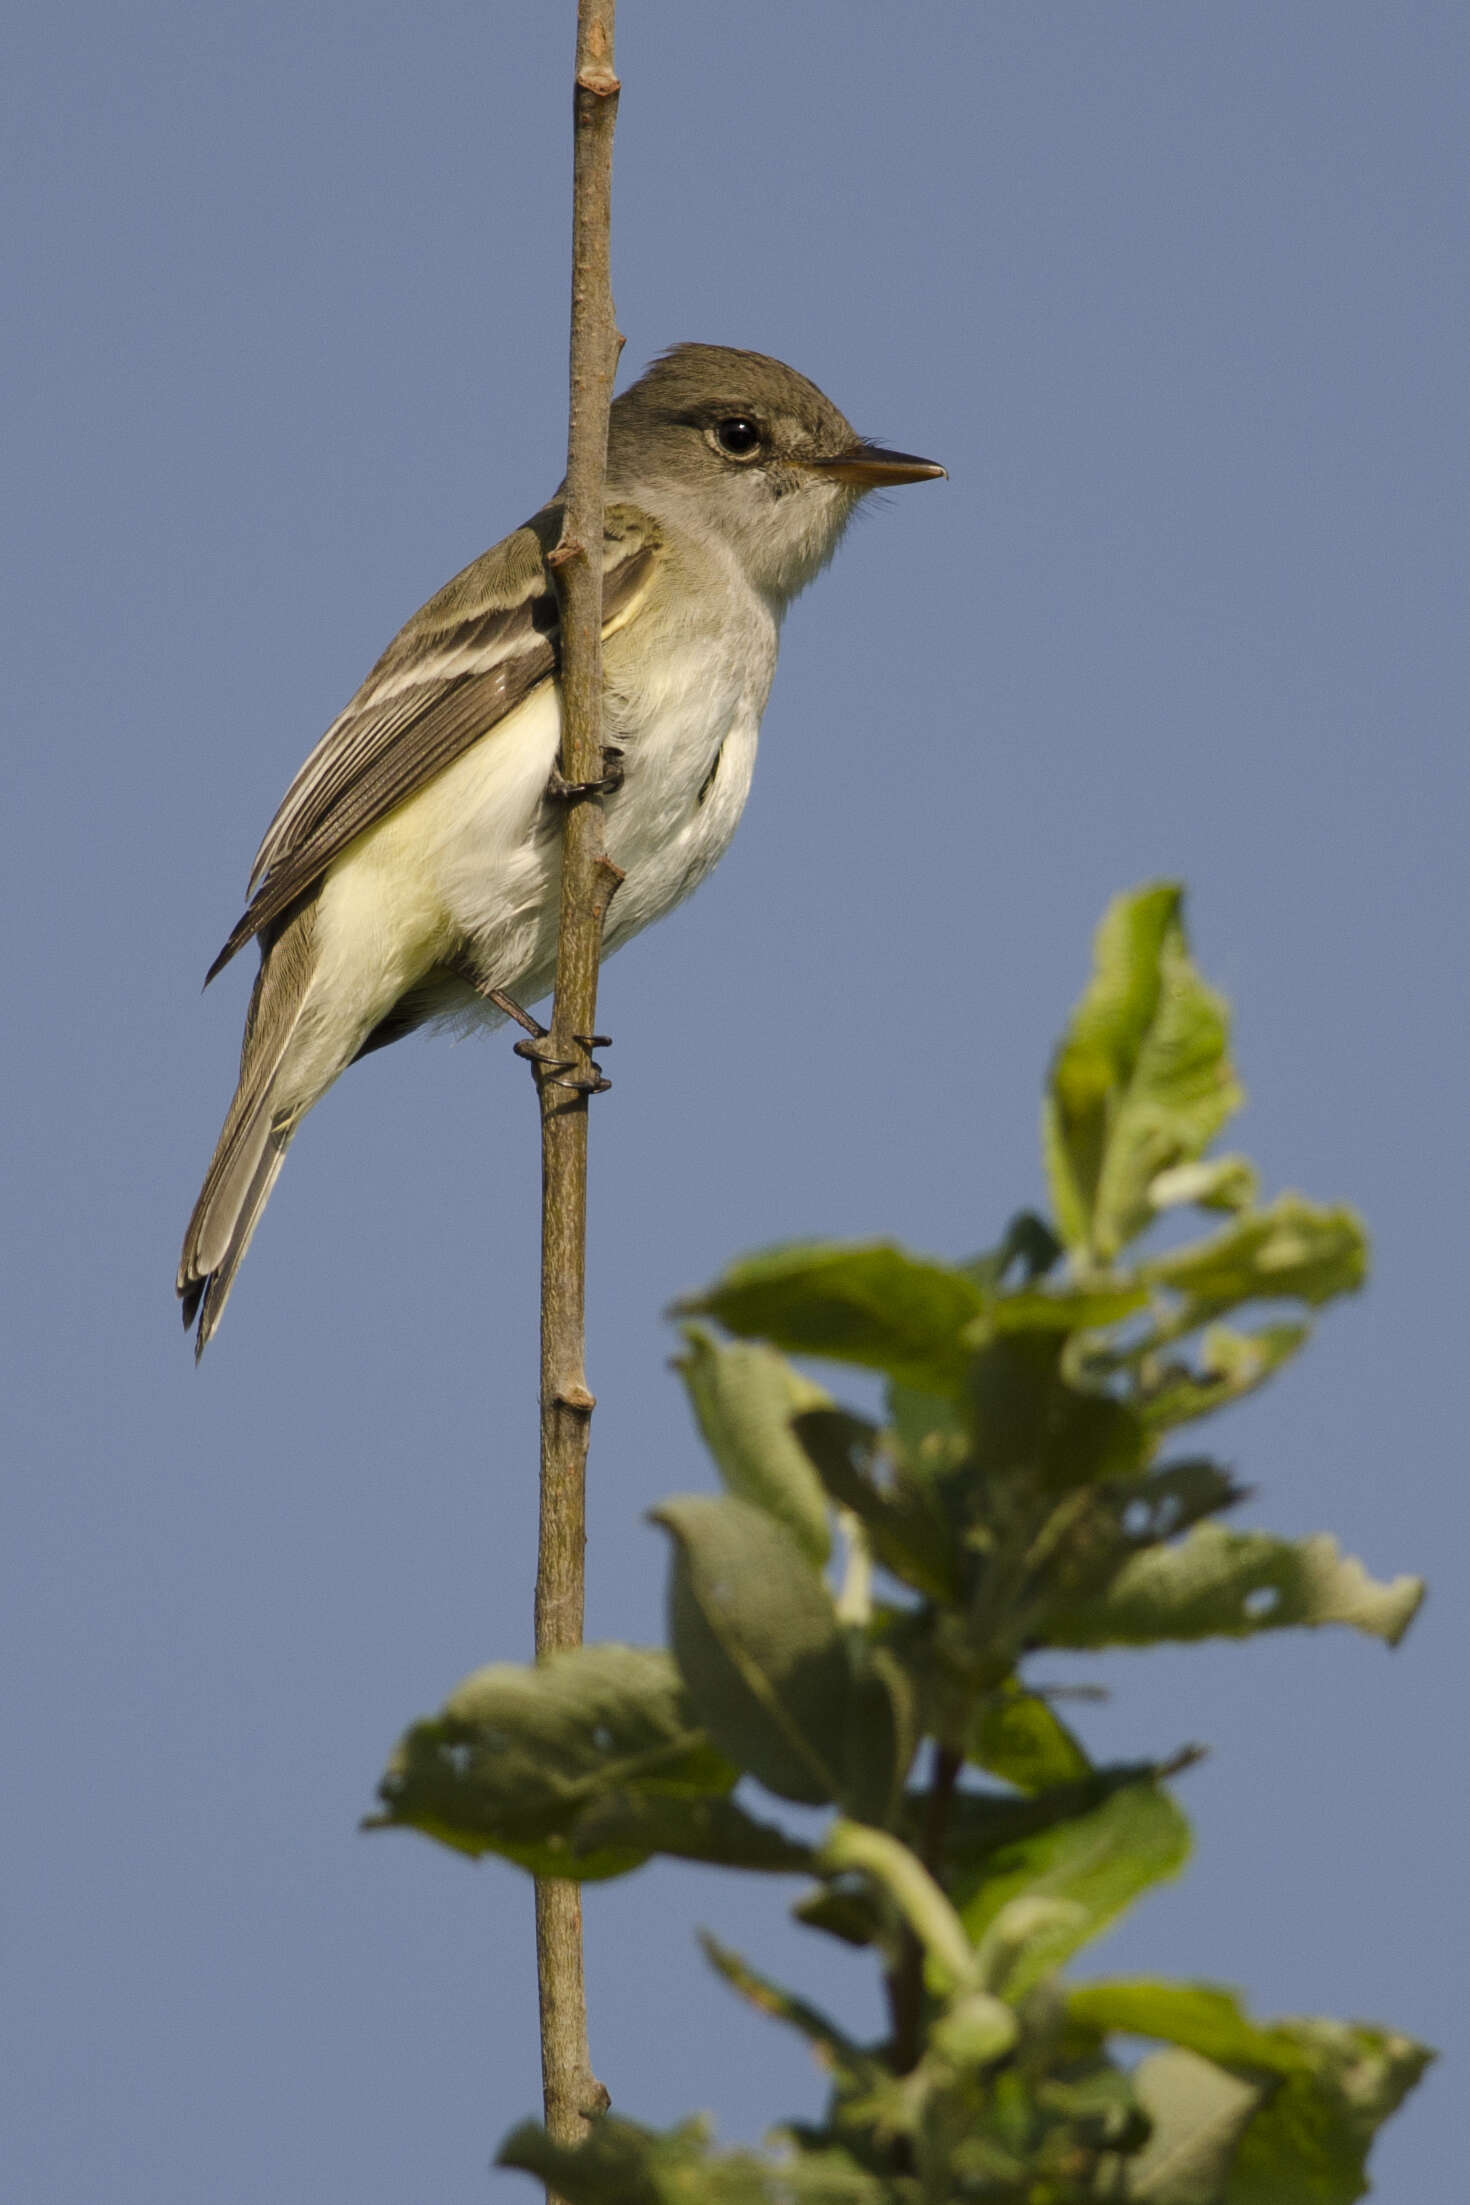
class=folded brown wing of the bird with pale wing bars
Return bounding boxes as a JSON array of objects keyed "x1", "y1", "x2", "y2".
[{"x1": 205, "y1": 505, "x2": 659, "y2": 986}]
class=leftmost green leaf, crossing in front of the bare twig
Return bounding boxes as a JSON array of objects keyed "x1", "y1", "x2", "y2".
[{"x1": 370, "y1": 1645, "x2": 736, "y2": 1879}]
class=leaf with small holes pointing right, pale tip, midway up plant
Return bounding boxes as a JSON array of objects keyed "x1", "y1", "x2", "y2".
[{"x1": 1047, "y1": 1524, "x2": 1424, "y2": 1647}]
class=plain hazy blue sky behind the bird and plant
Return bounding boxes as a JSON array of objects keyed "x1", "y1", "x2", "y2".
[{"x1": 0, "y1": 0, "x2": 1470, "y2": 2205}]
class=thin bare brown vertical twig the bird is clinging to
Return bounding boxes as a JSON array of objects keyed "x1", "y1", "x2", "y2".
[{"x1": 533, "y1": 0, "x2": 621, "y2": 2169}]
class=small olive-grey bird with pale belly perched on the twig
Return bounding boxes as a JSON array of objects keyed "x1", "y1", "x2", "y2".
[{"x1": 179, "y1": 344, "x2": 945, "y2": 1356}]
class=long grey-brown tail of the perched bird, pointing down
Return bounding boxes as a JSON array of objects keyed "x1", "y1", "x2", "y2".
[{"x1": 176, "y1": 904, "x2": 317, "y2": 1360}]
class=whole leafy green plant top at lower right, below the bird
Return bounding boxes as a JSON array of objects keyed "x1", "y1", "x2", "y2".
[{"x1": 377, "y1": 886, "x2": 1428, "y2": 2205}]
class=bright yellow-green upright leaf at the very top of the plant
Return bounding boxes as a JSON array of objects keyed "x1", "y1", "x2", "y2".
[{"x1": 1042, "y1": 882, "x2": 1241, "y2": 1263}]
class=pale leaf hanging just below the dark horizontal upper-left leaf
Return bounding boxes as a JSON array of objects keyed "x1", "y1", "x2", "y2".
[{"x1": 674, "y1": 1325, "x2": 831, "y2": 1566}]
